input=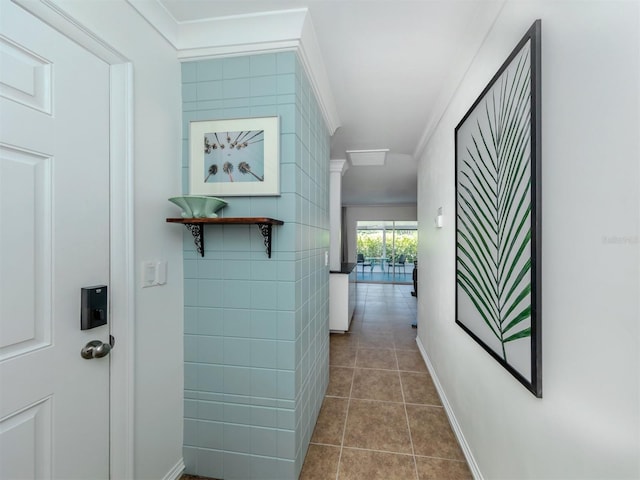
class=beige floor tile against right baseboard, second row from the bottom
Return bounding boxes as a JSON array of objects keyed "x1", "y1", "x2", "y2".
[{"x1": 406, "y1": 405, "x2": 464, "y2": 461}]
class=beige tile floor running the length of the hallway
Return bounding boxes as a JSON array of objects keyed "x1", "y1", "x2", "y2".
[{"x1": 300, "y1": 283, "x2": 473, "y2": 480}]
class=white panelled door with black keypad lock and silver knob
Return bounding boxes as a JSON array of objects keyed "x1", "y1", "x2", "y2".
[{"x1": 0, "y1": 0, "x2": 109, "y2": 480}]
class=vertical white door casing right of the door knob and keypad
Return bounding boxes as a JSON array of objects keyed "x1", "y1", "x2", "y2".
[{"x1": 110, "y1": 63, "x2": 135, "y2": 479}]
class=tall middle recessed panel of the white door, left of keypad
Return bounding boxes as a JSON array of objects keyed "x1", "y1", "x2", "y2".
[{"x1": 0, "y1": 145, "x2": 52, "y2": 360}]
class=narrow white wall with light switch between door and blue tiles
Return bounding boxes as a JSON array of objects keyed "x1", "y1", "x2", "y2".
[{"x1": 50, "y1": 0, "x2": 183, "y2": 480}]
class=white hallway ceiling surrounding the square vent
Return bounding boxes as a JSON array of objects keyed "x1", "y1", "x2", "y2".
[{"x1": 158, "y1": 0, "x2": 505, "y2": 205}]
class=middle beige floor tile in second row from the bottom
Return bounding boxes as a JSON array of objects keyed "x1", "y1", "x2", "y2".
[{"x1": 343, "y1": 399, "x2": 411, "y2": 453}]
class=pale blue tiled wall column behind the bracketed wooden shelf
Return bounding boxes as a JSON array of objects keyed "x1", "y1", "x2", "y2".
[{"x1": 182, "y1": 52, "x2": 329, "y2": 480}]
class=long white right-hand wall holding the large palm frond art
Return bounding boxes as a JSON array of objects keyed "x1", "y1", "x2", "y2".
[{"x1": 418, "y1": 1, "x2": 640, "y2": 480}]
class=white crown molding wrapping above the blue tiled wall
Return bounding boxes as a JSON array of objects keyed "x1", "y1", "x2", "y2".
[{"x1": 127, "y1": 0, "x2": 340, "y2": 135}]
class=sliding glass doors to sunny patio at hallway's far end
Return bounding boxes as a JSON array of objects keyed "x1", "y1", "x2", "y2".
[{"x1": 356, "y1": 220, "x2": 418, "y2": 284}]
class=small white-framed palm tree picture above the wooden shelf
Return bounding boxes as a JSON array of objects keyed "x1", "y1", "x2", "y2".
[{"x1": 189, "y1": 117, "x2": 280, "y2": 197}]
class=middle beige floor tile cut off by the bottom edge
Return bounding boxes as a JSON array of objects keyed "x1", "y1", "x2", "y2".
[{"x1": 339, "y1": 448, "x2": 416, "y2": 480}]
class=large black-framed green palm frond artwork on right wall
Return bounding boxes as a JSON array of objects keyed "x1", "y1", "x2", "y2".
[{"x1": 455, "y1": 20, "x2": 542, "y2": 398}]
